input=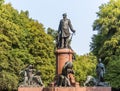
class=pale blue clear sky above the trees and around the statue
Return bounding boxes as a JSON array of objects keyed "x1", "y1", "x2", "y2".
[{"x1": 5, "y1": 0, "x2": 109, "y2": 55}]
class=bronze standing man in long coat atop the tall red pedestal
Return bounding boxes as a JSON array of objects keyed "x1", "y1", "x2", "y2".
[{"x1": 58, "y1": 13, "x2": 75, "y2": 48}]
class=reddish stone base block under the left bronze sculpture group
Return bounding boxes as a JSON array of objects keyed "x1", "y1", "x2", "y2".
[{"x1": 18, "y1": 86, "x2": 43, "y2": 91}]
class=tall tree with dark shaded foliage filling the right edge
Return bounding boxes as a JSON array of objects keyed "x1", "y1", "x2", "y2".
[{"x1": 91, "y1": 0, "x2": 120, "y2": 87}]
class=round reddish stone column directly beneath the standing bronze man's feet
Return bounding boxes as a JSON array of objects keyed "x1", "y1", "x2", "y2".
[{"x1": 55, "y1": 48, "x2": 74, "y2": 75}]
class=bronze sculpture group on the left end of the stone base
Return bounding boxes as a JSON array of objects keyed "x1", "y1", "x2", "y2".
[{"x1": 19, "y1": 65, "x2": 43, "y2": 86}]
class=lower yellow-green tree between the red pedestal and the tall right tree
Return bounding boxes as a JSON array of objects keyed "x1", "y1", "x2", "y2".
[{"x1": 73, "y1": 53, "x2": 97, "y2": 85}]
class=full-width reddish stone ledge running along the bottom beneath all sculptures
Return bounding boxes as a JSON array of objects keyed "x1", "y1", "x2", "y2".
[{"x1": 18, "y1": 87, "x2": 111, "y2": 91}]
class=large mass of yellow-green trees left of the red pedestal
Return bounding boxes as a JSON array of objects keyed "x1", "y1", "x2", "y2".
[{"x1": 0, "y1": 4, "x2": 55, "y2": 88}]
